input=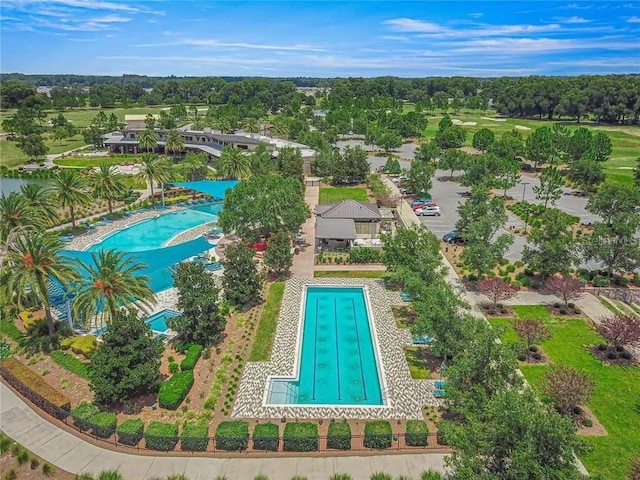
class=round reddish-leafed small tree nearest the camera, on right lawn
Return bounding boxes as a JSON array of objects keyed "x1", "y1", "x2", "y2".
[{"x1": 542, "y1": 365, "x2": 595, "y2": 414}]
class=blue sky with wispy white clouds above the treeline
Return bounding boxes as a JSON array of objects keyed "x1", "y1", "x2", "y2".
[{"x1": 0, "y1": 0, "x2": 640, "y2": 77}]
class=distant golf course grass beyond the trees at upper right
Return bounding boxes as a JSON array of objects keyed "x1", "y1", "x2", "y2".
[{"x1": 423, "y1": 112, "x2": 640, "y2": 184}]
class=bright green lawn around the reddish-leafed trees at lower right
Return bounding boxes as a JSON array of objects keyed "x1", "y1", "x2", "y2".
[{"x1": 491, "y1": 306, "x2": 640, "y2": 480}]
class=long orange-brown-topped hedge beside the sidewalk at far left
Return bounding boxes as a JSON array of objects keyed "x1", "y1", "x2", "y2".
[{"x1": 0, "y1": 357, "x2": 71, "y2": 418}]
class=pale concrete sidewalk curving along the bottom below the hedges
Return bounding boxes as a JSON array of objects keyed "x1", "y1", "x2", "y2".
[{"x1": 0, "y1": 383, "x2": 445, "y2": 480}]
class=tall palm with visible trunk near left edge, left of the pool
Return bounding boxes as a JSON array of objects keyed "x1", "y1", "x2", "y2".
[{"x1": 5, "y1": 232, "x2": 78, "y2": 335}]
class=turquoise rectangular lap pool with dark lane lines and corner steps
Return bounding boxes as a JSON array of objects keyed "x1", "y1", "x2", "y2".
[{"x1": 267, "y1": 287, "x2": 383, "y2": 405}]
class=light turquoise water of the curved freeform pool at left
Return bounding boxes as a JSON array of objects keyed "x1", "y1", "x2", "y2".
[{"x1": 87, "y1": 203, "x2": 222, "y2": 252}]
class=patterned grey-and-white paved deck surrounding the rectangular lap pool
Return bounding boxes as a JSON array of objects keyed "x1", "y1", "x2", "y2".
[{"x1": 232, "y1": 278, "x2": 439, "y2": 419}]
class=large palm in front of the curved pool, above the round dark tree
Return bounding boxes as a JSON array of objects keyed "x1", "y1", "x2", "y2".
[{"x1": 73, "y1": 250, "x2": 155, "y2": 325}]
